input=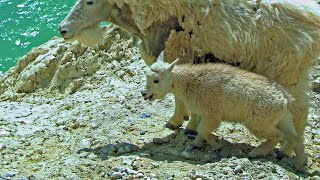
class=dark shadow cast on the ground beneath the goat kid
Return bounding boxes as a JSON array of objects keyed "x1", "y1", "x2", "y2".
[{"x1": 78, "y1": 129, "x2": 313, "y2": 177}]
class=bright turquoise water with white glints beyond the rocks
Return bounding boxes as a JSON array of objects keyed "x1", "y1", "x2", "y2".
[{"x1": 0, "y1": 0, "x2": 76, "y2": 74}]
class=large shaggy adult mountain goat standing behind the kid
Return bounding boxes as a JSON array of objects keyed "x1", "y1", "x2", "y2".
[{"x1": 60, "y1": 0, "x2": 320, "y2": 154}]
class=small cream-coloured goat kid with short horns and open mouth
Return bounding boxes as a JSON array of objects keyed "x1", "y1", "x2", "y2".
[{"x1": 142, "y1": 53, "x2": 307, "y2": 170}]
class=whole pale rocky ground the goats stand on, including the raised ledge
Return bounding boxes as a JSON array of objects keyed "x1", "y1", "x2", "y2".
[{"x1": 0, "y1": 26, "x2": 320, "y2": 179}]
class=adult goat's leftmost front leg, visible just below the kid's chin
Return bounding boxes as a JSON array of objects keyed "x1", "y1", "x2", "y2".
[{"x1": 165, "y1": 96, "x2": 189, "y2": 130}]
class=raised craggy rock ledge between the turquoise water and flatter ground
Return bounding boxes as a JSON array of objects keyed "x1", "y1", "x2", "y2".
[{"x1": 0, "y1": 25, "x2": 138, "y2": 100}]
